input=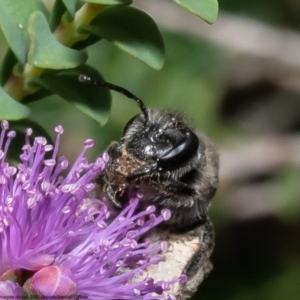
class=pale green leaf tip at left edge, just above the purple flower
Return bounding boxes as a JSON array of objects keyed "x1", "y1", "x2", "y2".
[{"x1": 0, "y1": 87, "x2": 30, "y2": 120}]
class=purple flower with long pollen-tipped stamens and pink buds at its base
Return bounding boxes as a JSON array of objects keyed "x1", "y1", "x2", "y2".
[{"x1": 0, "y1": 121, "x2": 186, "y2": 299}]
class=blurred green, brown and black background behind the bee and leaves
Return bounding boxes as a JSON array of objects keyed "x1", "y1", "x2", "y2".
[{"x1": 0, "y1": 0, "x2": 300, "y2": 300}]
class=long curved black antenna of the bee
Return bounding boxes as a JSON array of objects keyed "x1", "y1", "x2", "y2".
[{"x1": 78, "y1": 75, "x2": 149, "y2": 122}]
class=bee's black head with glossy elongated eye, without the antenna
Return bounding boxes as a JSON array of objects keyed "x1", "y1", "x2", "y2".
[{"x1": 122, "y1": 110, "x2": 200, "y2": 171}]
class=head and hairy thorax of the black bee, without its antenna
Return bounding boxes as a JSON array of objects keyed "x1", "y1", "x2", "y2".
[{"x1": 97, "y1": 110, "x2": 218, "y2": 232}]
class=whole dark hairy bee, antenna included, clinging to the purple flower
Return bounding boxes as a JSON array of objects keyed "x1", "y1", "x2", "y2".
[{"x1": 79, "y1": 75, "x2": 219, "y2": 299}]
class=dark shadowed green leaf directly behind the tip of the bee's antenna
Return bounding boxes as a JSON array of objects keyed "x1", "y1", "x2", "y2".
[{"x1": 30, "y1": 65, "x2": 111, "y2": 125}]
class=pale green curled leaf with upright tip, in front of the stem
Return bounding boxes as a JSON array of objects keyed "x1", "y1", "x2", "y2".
[{"x1": 28, "y1": 12, "x2": 87, "y2": 69}]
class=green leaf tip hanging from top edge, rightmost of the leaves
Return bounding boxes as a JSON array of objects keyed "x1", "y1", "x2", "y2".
[{"x1": 172, "y1": 0, "x2": 219, "y2": 24}]
